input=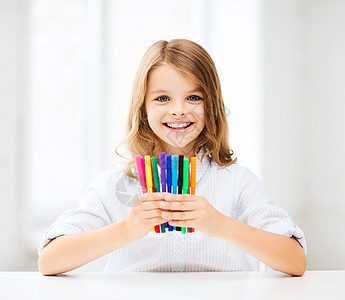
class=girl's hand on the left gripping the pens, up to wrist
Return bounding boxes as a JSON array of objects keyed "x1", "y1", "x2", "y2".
[{"x1": 124, "y1": 193, "x2": 168, "y2": 240}]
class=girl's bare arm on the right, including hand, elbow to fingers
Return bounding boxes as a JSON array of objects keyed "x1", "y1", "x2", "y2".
[{"x1": 160, "y1": 194, "x2": 307, "y2": 276}]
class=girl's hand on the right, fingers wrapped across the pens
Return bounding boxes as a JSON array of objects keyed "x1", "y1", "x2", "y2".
[{"x1": 159, "y1": 193, "x2": 225, "y2": 236}]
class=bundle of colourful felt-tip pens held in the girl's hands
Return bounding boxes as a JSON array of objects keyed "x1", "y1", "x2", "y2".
[{"x1": 135, "y1": 152, "x2": 196, "y2": 234}]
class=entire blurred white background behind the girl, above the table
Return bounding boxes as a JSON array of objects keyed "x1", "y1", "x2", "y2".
[{"x1": 0, "y1": 0, "x2": 345, "y2": 271}]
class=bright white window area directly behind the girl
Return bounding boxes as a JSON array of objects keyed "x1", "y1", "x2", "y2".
[{"x1": 27, "y1": 0, "x2": 262, "y2": 270}]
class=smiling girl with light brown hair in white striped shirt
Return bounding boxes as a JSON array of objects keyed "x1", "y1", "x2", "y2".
[{"x1": 38, "y1": 39, "x2": 306, "y2": 276}]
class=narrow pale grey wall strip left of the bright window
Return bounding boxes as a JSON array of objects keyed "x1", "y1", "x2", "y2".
[{"x1": 0, "y1": 0, "x2": 27, "y2": 270}]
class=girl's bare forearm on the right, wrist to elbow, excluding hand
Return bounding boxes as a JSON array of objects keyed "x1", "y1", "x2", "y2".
[{"x1": 217, "y1": 215, "x2": 307, "y2": 276}]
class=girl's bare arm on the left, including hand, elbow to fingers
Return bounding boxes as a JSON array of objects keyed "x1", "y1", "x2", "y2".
[{"x1": 38, "y1": 194, "x2": 165, "y2": 275}]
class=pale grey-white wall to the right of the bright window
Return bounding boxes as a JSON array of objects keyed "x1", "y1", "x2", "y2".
[{"x1": 262, "y1": 0, "x2": 345, "y2": 269}]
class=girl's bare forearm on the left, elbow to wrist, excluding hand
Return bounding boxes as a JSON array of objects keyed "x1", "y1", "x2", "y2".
[{"x1": 38, "y1": 221, "x2": 133, "y2": 275}]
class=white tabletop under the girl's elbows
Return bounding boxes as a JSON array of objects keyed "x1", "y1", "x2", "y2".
[{"x1": 0, "y1": 271, "x2": 345, "y2": 300}]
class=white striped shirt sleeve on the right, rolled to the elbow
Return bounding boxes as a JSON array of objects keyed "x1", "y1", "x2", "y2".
[{"x1": 236, "y1": 167, "x2": 307, "y2": 253}]
